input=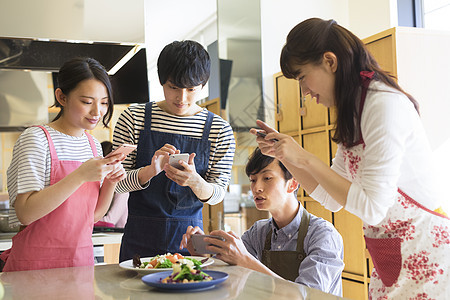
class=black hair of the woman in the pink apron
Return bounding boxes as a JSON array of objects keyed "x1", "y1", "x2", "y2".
[{"x1": 53, "y1": 57, "x2": 114, "y2": 128}]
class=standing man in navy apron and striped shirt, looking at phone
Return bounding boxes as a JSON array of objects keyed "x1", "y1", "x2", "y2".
[{"x1": 114, "y1": 41, "x2": 235, "y2": 261}]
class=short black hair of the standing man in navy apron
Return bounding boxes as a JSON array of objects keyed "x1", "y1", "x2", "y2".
[{"x1": 158, "y1": 40, "x2": 211, "y2": 88}]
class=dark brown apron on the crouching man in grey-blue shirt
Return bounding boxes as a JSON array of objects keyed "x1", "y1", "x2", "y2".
[{"x1": 261, "y1": 208, "x2": 310, "y2": 281}]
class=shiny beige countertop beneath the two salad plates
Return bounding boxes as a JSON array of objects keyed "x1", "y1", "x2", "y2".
[{"x1": 0, "y1": 260, "x2": 342, "y2": 300}]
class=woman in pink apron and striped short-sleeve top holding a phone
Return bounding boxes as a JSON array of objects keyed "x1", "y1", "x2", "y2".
[{"x1": 0, "y1": 58, "x2": 126, "y2": 272}]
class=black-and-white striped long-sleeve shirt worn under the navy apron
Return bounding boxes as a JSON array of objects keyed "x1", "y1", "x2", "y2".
[{"x1": 113, "y1": 102, "x2": 235, "y2": 205}]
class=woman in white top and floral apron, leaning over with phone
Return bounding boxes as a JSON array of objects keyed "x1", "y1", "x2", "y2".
[{"x1": 251, "y1": 18, "x2": 450, "y2": 299}]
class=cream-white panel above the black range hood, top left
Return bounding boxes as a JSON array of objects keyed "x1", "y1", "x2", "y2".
[{"x1": 0, "y1": 0, "x2": 144, "y2": 43}]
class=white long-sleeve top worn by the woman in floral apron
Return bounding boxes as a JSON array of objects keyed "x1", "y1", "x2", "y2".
[{"x1": 310, "y1": 81, "x2": 440, "y2": 225}]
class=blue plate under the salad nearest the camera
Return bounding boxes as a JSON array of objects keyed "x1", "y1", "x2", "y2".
[{"x1": 142, "y1": 270, "x2": 228, "y2": 290}]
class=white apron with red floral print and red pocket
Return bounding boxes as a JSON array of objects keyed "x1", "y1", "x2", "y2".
[{"x1": 344, "y1": 72, "x2": 450, "y2": 299}]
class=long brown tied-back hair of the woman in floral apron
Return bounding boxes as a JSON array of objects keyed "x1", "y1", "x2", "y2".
[{"x1": 280, "y1": 18, "x2": 419, "y2": 147}]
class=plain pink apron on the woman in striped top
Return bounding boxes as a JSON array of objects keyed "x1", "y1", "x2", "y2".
[{"x1": 0, "y1": 126, "x2": 100, "y2": 272}]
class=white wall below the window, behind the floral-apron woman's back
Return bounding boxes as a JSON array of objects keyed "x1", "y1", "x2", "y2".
[{"x1": 397, "y1": 27, "x2": 450, "y2": 212}]
